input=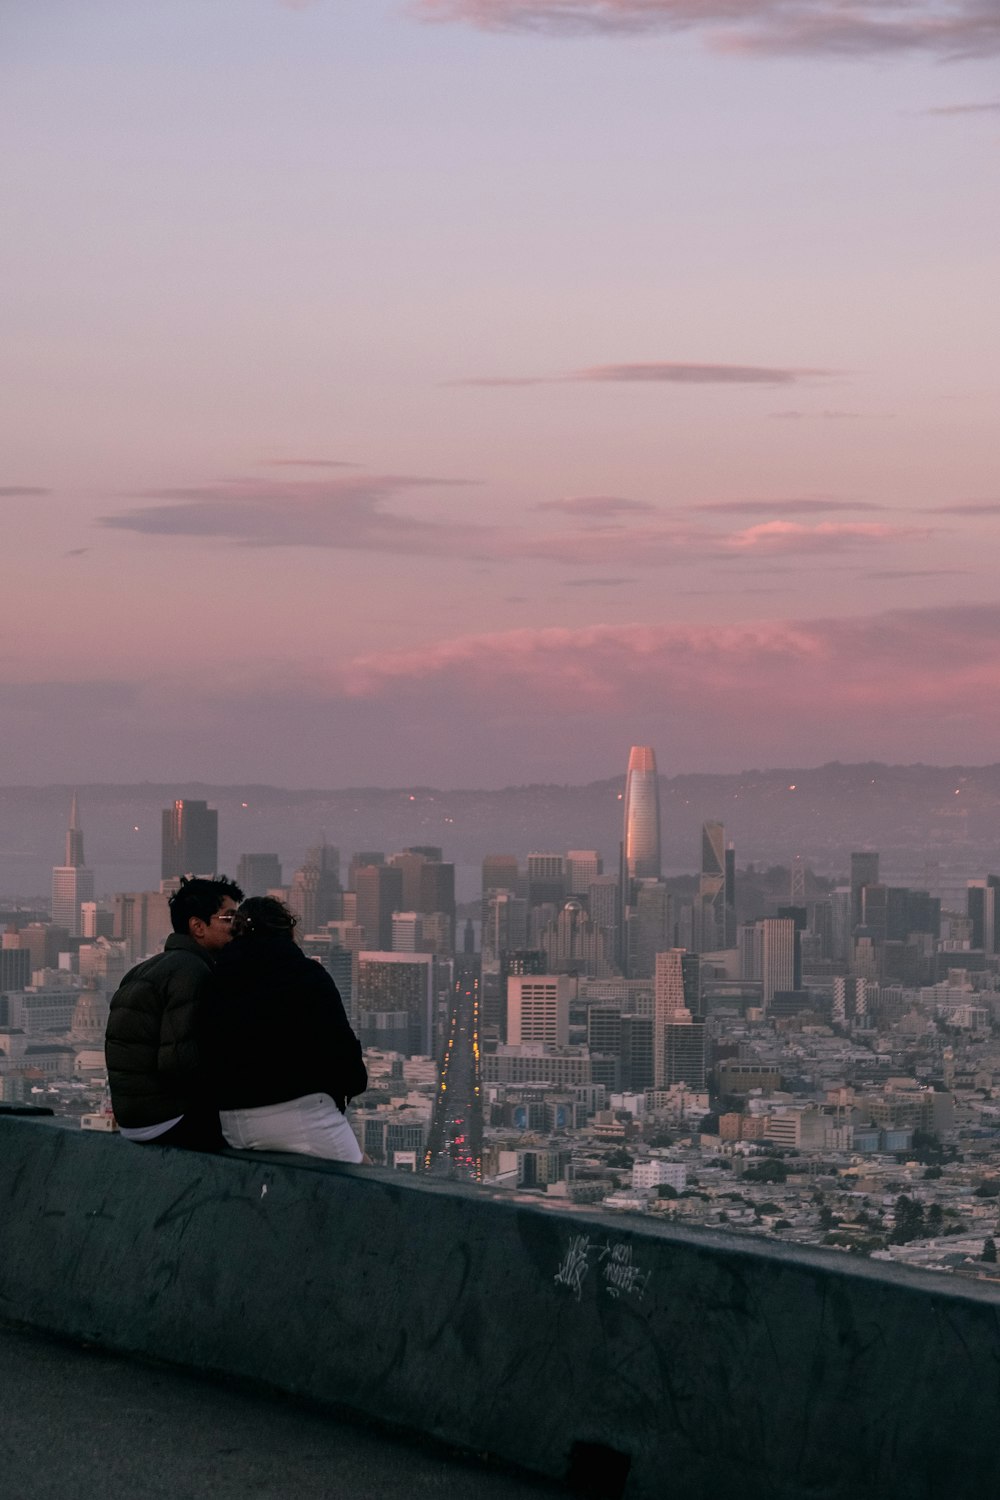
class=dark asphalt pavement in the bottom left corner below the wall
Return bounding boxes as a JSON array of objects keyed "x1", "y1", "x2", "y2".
[{"x1": 0, "y1": 1325, "x2": 561, "y2": 1500}]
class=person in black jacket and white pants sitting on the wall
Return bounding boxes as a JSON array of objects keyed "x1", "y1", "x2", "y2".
[{"x1": 205, "y1": 896, "x2": 367, "y2": 1163}]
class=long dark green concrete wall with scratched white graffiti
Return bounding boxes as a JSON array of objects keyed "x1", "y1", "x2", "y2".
[{"x1": 0, "y1": 1118, "x2": 1000, "y2": 1500}]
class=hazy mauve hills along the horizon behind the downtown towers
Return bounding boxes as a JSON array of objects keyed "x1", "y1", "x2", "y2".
[{"x1": 0, "y1": 761, "x2": 1000, "y2": 900}]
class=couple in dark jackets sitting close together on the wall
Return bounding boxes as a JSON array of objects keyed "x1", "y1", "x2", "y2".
[{"x1": 105, "y1": 876, "x2": 367, "y2": 1163}]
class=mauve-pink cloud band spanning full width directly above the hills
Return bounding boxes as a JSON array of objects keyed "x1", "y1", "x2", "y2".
[{"x1": 4, "y1": 606, "x2": 1000, "y2": 786}]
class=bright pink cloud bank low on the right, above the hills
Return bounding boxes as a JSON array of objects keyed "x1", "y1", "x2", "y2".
[{"x1": 330, "y1": 606, "x2": 1000, "y2": 735}]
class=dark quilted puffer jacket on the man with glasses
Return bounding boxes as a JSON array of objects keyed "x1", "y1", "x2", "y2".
[{"x1": 105, "y1": 933, "x2": 213, "y2": 1130}]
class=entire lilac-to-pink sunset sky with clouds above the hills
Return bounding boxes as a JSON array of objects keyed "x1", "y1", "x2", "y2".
[{"x1": 0, "y1": 0, "x2": 1000, "y2": 786}]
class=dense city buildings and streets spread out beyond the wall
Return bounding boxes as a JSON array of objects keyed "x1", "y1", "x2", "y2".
[{"x1": 9, "y1": 746, "x2": 1000, "y2": 1281}]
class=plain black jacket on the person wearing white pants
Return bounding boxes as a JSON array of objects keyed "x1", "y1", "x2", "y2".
[{"x1": 202, "y1": 935, "x2": 367, "y2": 1110}]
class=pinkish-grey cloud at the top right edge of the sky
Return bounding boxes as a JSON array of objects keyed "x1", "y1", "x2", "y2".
[{"x1": 409, "y1": 0, "x2": 1000, "y2": 57}]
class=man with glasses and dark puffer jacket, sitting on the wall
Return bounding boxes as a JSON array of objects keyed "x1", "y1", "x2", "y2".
[{"x1": 105, "y1": 876, "x2": 243, "y2": 1151}]
